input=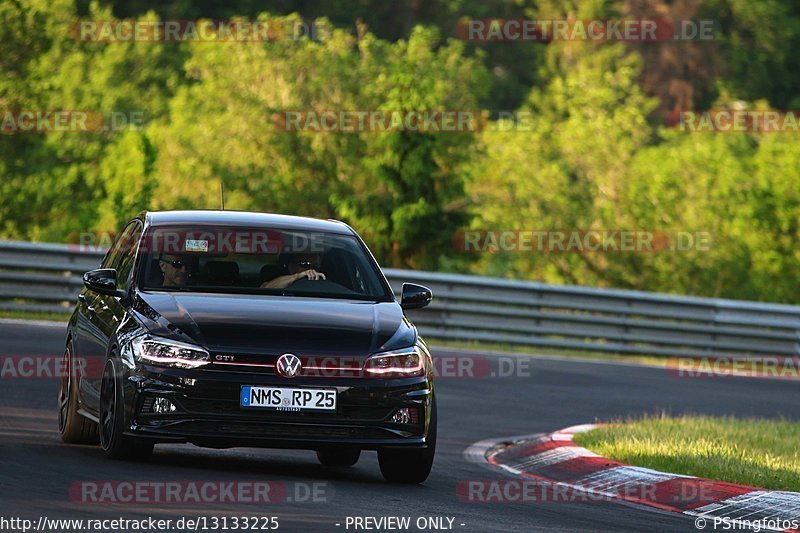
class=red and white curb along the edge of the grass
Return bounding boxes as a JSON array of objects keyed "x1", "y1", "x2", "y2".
[{"x1": 464, "y1": 424, "x2": 800, "y2": 531}]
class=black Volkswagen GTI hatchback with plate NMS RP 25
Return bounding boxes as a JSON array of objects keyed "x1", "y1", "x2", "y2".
[{"x1": 59, "y1": 211, "x2": 436, "y2": 483}]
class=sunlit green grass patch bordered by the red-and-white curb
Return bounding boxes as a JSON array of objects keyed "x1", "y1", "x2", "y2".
[{"x1": 575, "y1": 415, "x2": 800, "y2": 491}]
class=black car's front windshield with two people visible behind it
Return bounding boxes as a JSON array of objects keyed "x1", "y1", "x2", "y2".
[{"x1": 139, "y1": 223, "x2": 393, "y2": 301}]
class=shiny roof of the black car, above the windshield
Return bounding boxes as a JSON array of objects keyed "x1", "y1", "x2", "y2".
[{"x1": 144, "y1": 209, "x2": 354, "y2": 235}]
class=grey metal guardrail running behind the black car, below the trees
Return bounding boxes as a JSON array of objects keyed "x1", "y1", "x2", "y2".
[{"x1": 0, "y1": 242, "x2": 800, "y2": 356}]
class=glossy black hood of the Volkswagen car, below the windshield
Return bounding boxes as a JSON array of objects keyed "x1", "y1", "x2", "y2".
[{"x1": 134, "y1": 292, "x2": 416, "y2": 356}]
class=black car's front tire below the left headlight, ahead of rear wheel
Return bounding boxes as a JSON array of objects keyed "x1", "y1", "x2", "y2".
[{"x1": 99, "y1": 359, "x2": 153, "y2": 460}]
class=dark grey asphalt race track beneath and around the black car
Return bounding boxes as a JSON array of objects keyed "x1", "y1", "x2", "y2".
[{"x1": 0, "y1": 322, "x2": 800, "y2": 532}]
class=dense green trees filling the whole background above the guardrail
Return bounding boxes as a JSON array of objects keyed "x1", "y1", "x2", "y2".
[{"x1": 0, "y1": 0, "x2": 800, "y2": 303}]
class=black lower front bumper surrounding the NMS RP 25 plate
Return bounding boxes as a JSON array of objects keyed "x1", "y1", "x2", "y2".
[{"x1": 123, "y1": 364, "x2": 433, "y2": 450}]
